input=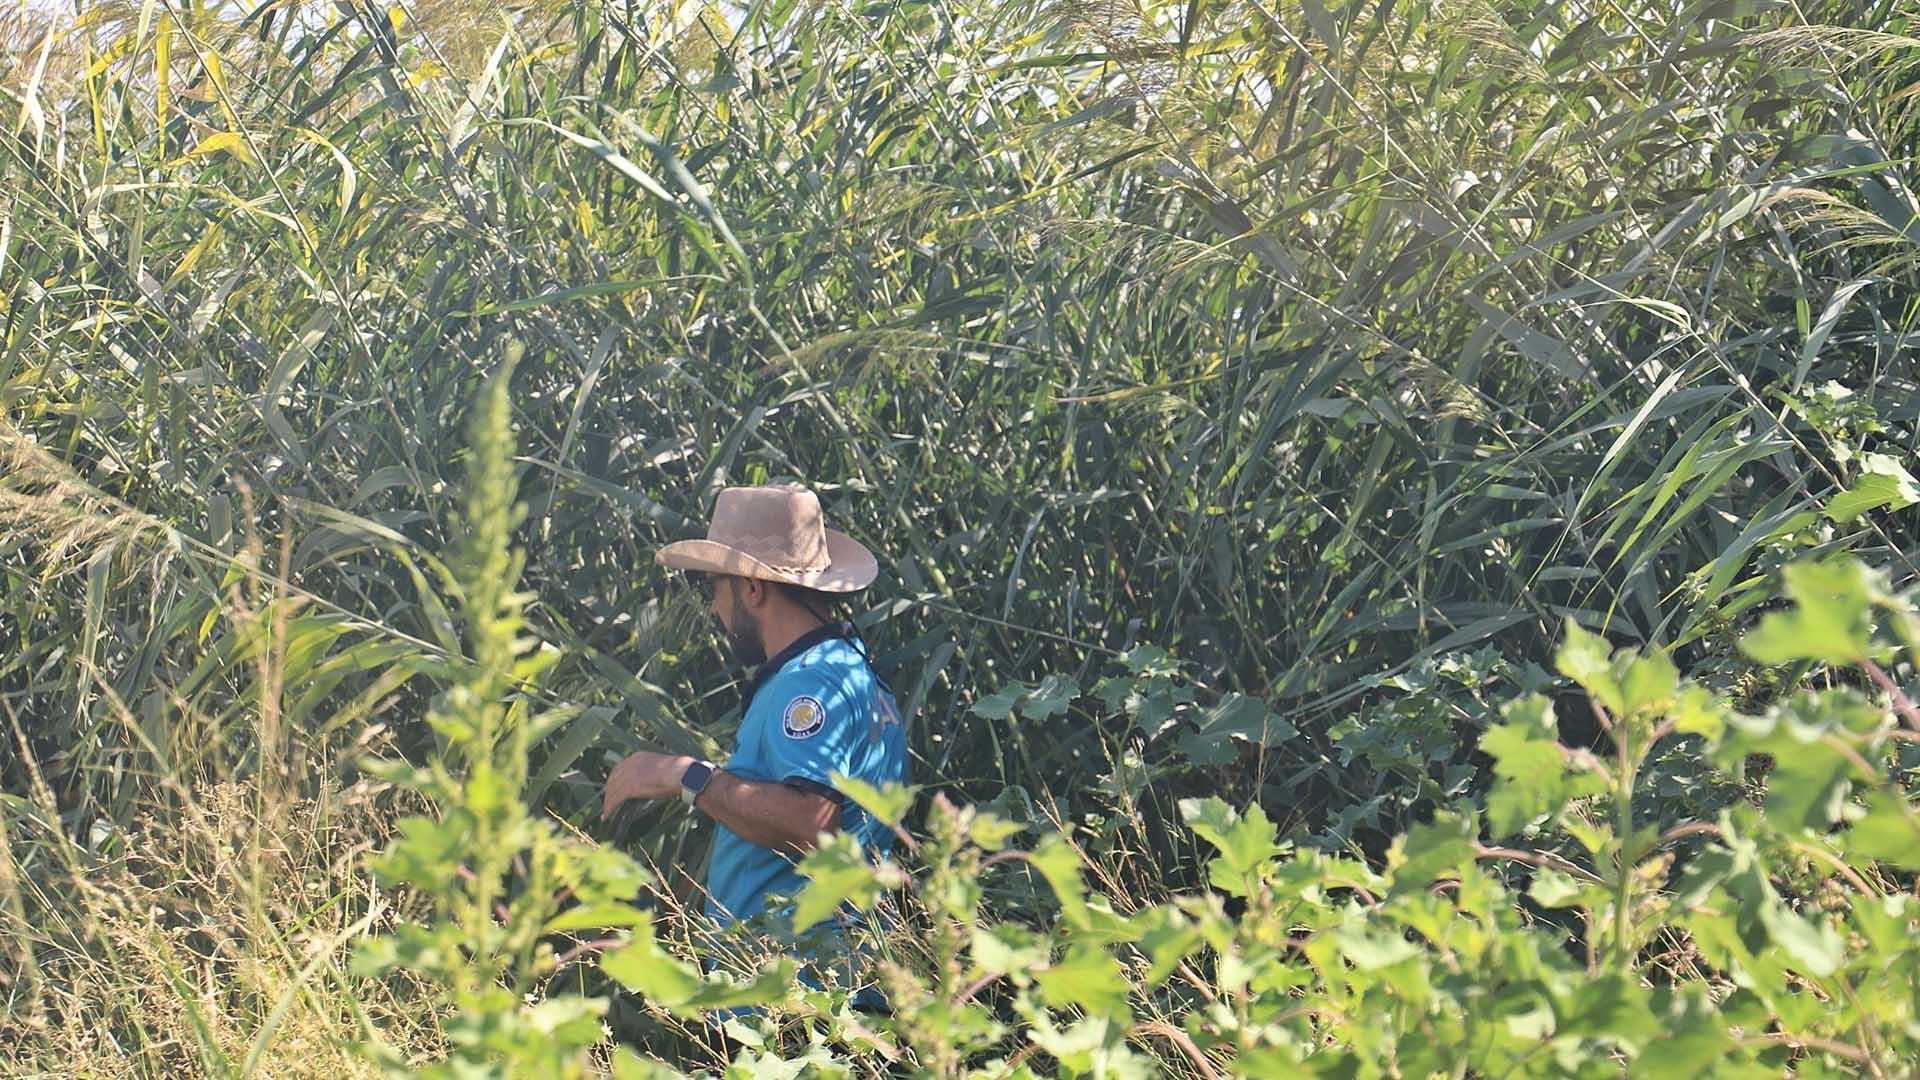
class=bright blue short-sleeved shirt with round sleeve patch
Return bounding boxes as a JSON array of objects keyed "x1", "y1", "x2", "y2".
[{"x1": 707, "y1": 626, "x2": 906, "y2": 924}]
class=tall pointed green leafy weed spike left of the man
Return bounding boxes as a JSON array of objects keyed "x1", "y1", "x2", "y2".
[{"x1": 353, "y1": 359, "x2": 675, "y2": 1078}]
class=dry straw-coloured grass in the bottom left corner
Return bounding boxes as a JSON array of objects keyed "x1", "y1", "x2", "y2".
[{"x1": 0, "y1": 760, "x2": 440, "y2": 1078}]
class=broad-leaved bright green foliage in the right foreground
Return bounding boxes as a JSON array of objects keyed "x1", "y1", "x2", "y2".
[{"x1": 714, "y1": 567, "x2": 1920, "y2": 1076}]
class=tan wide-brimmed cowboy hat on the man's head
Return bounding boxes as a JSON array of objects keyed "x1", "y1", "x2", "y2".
[{"x1": 653, "y1": 484, "x2": 879, "y2": 592}]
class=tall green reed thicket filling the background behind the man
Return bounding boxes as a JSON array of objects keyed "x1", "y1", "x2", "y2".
[{"x1": 0, "y1": 0, "x2": 1920, "y2": 1070}]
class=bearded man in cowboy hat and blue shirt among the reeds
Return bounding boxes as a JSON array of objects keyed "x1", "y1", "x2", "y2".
[{"x1": 601, "y1": 486, "x2": 906, "y2": 926}]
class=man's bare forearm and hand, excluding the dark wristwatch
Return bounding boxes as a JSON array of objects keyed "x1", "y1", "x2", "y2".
[{"x1": 601, "y1": 749, "x2": 841, "y2": 855}]
